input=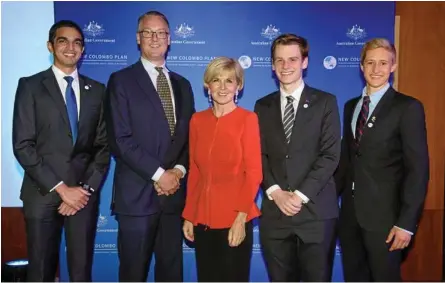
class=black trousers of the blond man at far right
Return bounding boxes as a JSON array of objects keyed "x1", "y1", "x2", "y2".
[{"x1": 339, "y1": 206, "x2": 402, "y2": 282}]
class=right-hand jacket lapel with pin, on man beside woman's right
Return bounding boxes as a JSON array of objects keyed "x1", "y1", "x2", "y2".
[{"x1": 289, "y1": 85, "x2": 317, "y2": 148}]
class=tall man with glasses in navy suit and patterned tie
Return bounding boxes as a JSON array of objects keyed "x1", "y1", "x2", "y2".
[{"x1": 106, "y1": 11, "x2": 195, "y2": 281}]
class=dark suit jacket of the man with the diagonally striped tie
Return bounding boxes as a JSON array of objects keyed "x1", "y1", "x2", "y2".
[{"x1": 255, "y1": 85, "x2": 340, "y2": 231}]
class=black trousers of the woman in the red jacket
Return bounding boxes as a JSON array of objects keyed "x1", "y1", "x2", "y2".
[{"x1": 194, "y1": 222, "x2": 253, "y2": 282}]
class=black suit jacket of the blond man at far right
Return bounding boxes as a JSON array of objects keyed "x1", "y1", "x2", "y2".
[{"x1": 336, "y1": 88, "x2": 429, "y2": 232}]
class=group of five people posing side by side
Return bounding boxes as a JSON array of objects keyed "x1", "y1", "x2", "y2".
[{"x1": 13, "y1": 8, "x2": 429, "y2": 282}]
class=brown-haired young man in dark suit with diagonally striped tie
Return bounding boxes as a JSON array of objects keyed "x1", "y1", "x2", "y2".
[{"x1": 255, "y1": 34, "x2": 340, "y2": 281}]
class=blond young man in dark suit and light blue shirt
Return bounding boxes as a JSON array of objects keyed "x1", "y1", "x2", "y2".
[{"x1": 335, "y1": 39, "x2": 429, "y2": 281}]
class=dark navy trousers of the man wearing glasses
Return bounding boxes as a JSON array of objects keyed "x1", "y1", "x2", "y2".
[{"x1": 117, "y1": 212, "x2": 183, "y2": 282}]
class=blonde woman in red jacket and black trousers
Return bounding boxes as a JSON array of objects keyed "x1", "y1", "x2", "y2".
[{"x1": 183, "y1": 57, "x2": 262, "y2": 282}]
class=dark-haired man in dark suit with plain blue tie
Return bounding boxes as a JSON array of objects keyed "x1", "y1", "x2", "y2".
[{"x1": 13, "y1": 21, "x2": 110, "y2": 281}]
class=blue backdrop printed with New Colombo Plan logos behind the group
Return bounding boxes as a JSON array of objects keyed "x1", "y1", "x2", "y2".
[{"x1": 55, "y1": 1, "x2": 395, "y2": 282}]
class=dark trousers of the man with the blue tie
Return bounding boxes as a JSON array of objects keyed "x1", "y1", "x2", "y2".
[{"x1": 23, "y1": 197, "x2": 98, "y2": 282}]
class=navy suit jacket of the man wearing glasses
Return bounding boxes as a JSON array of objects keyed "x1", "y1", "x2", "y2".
[{"x1": 105, "y1": 61, "x2": 195, "y2": 216}]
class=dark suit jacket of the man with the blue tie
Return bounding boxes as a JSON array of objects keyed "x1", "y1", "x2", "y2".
[{"x1": 13, "y1": 68, "x2": 110, "y2": 203}]
